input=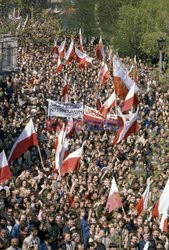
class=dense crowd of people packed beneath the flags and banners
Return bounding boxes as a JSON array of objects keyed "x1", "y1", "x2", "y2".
[{"x1": 0, "y1": 30, "x2": 169, "y2": 250}]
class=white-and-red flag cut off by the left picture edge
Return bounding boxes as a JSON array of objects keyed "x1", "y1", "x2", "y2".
[{"x1": 0, "y1": 150, "x2": 12, "y2": 183}]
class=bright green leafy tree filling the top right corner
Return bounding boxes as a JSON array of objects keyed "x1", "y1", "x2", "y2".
[{"x1": 114, "y1": 0, "x2": 169, "y2": 56}]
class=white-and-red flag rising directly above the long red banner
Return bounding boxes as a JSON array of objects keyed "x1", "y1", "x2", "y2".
[{"x1": 100, "y1": 92, "x2": 117, "y2": 117}]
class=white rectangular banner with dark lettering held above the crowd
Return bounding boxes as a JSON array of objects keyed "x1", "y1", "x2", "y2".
[{"x1": 47, "y1": 99, "x2": 84, "y2": 118}]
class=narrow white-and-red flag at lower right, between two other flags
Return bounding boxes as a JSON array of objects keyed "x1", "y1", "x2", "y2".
[{"x1": 136, "y1": 184, "x2": 151, "y2": 215}]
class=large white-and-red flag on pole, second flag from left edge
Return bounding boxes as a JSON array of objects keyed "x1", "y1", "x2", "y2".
[{"x1": 8, "y1": 119, "x2": 38, "y2": 165}]
